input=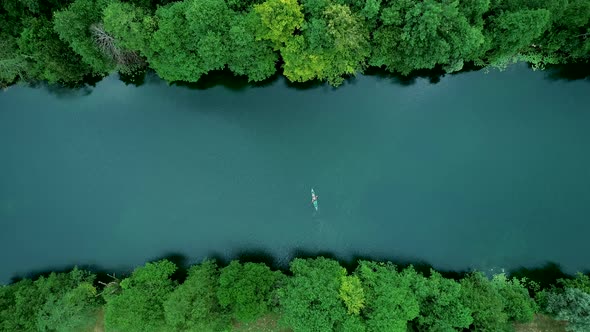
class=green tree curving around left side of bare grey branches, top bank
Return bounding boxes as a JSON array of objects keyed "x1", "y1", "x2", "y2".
[{"x1": 53, "y1": 0, "x2": 116, "y2": 75}]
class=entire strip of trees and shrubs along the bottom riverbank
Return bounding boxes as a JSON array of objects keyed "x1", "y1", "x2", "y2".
[{"x1": 0, "y1": 256, "x2": 590, "y2": 332}]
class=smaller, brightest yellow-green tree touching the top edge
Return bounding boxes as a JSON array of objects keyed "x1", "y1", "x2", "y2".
[{"x1": 254, "y1": 0, "x2": 303, "y2": 49}]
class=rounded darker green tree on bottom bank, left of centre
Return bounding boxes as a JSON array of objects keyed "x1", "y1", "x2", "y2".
[{"x1": 217, "y1": 261, "x2": 284, "y2": 322}]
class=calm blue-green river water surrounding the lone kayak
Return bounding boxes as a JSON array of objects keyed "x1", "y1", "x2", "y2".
[{"x1": 0, "y1": 65, "x2": 590, "y2": 282}]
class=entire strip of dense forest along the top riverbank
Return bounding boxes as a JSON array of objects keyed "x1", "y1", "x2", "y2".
[{"x1": 0, "y1": 0, "x2": 590, "y2": 87}]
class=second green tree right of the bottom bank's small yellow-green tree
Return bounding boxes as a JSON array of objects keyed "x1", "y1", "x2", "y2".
[{"x1": 414, "y1": 270, "x2": 473, "y2": 332}]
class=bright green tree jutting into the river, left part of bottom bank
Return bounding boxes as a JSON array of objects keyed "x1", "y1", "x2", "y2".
[{"x1": 105, "y1": 260, "x2": 176, "y2": 332}]
